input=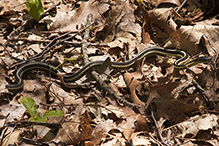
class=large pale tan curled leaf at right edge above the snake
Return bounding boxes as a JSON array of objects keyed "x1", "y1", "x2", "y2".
[{"x1": 165, "y1": 18, "x2": 219, "y2": 56}]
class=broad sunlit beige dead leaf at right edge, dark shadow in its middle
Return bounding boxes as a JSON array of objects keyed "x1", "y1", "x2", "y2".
[{"x1": 180, "y1": 20, "x2": 219, "y2": 56}]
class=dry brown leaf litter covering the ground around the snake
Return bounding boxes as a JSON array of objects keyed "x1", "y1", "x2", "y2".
[{"x1": 0, "y1": 0, "x2": 219, "y2": 146}]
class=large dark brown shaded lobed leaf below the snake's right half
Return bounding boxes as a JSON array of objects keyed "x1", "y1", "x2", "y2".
[{"x1": 146, "y1": 82, "x2": 199, "y2": 123}]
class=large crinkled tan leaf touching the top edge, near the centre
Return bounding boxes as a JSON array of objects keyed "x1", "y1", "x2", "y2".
[{"x1": 97, "y1": 0, "x2": 141, "y2": 42}]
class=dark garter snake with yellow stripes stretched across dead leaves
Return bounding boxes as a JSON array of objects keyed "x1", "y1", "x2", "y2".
[{"x1": 6, "y1": 47, "x2": 211, "y2": 91}]
